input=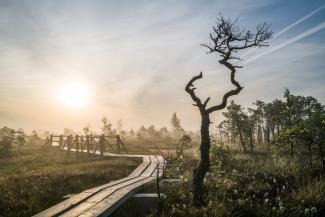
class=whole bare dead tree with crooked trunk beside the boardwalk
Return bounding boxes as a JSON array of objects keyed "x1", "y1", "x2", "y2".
[{"x1": 185, "y1": 16, "x2": 272, "y2": 207}]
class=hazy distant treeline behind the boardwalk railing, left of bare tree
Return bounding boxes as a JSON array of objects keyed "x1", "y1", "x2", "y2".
[{"x1": 0, "y1": 113, "x2": 200, "y2": 152}]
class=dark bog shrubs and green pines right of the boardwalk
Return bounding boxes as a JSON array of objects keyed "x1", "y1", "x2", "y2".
[{"x1": 155, "y1": 90, "x2": 325, "y2": 217}]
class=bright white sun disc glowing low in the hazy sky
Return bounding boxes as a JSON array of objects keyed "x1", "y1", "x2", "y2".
[{"x1": 59, "y1": 83, "x2": 89, "y2": 109}]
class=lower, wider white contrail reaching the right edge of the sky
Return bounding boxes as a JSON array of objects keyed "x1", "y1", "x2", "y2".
[{"x1": 243, "y1": 21, "x2": 325, "y2": 65}]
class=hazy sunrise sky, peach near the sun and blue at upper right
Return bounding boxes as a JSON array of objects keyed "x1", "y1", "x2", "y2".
[{"x1": 0, "y1": 0, "x2": 325, "y2": 132}]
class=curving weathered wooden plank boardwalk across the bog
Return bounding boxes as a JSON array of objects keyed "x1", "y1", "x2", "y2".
[{"x1": 34, "y1": 150, "x2": 165, "y2": 217}]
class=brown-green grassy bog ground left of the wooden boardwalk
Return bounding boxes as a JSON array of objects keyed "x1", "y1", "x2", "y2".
[{"x1": 0, "y1": 146, "x2": 141, "y2": 216}]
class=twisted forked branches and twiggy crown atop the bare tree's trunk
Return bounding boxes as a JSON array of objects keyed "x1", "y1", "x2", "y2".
[{"x1": 185, "y1": 16, "x2": 273, "y2": 114}]
